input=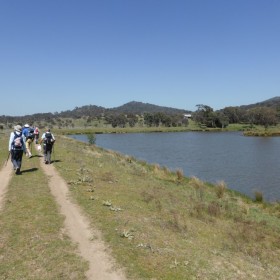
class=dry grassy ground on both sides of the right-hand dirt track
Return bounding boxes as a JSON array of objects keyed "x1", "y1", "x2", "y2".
[{"x1": 0, "y1": 130, "x2": 280, "y2": 280}]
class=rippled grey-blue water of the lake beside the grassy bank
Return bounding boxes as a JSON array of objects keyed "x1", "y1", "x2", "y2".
[{"x1": 72, "y1": 132, "x2": 280, "y2": 201}]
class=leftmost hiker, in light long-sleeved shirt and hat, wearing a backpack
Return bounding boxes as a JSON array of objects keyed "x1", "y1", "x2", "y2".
[{"x1": 9, "y1": 125, "x2": 26, "y2": 175}]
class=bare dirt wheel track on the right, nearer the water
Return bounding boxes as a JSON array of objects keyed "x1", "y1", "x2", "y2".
[{"x1": 40, "y1": 159, "x2": 126, "y2": 280}]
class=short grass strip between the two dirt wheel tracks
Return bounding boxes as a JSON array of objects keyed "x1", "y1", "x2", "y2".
[{"x1": 0, "y1": 134, "x2": 87, "y2": 280}]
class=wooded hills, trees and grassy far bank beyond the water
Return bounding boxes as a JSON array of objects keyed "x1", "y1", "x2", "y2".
[{"x1": 0, "y1": 100, "x2": 280, "y2": 136}]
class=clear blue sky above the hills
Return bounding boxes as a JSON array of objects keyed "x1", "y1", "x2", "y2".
[{"x1": 0, "y1": 0, "x2": 280, "y2": 116}]
